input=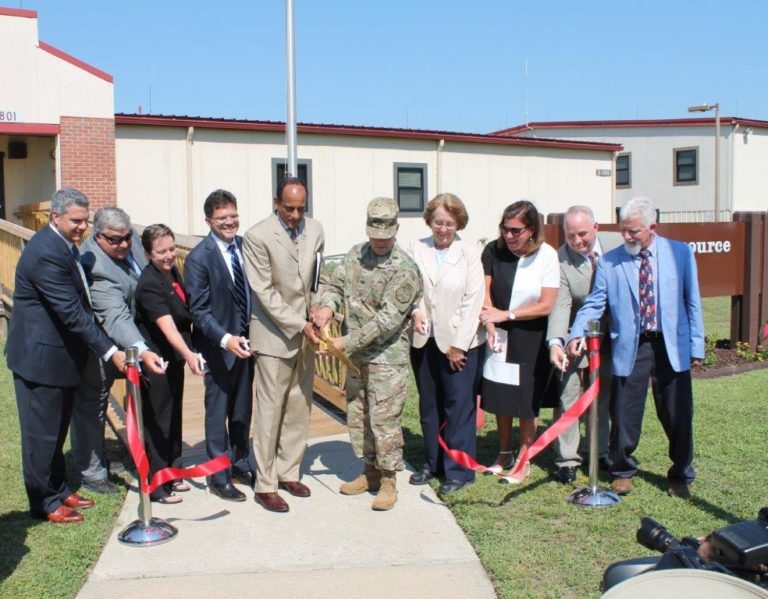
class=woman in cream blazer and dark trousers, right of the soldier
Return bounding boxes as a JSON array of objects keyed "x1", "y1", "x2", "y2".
[{"x1": 408, "y1": 193, "x2": 484, "y2": 494}]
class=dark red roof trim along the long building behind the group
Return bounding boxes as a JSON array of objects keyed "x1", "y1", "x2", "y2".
[{"x1": 115, "y1": 114, "x2": 623, "y2": 152}]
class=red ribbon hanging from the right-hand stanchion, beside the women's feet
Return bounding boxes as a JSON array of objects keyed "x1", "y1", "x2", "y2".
[{"x1": 437, "y1": 336, "x2": 600, "y2": 476}]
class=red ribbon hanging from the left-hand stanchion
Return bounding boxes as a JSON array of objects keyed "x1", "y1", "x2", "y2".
[{"x1": 125, "y1": 364, "x2": 232, "y2": 493}]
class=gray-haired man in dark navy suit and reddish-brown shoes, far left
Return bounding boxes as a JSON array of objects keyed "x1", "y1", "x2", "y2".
[{"x1": 5, "y1": 189, "x2": 125, "y2": 523}]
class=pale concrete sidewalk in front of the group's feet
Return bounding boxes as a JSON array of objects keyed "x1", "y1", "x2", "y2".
[{"x1": 78, "y1": 435, "x2": 496, "y2": 599}]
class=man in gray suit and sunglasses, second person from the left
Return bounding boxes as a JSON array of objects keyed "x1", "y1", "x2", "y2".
[{"x1": 70, "y1": 206, "x2": 163, "y2": 493}]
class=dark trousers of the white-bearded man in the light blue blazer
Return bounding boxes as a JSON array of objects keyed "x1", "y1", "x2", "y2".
[{"x1": 611, "y1": 336, "x2": 696, "y2": 482}]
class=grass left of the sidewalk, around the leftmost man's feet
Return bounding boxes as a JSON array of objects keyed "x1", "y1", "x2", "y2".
[{"x1": 0, "y1": 344, "x2": 125, "y2": 599}]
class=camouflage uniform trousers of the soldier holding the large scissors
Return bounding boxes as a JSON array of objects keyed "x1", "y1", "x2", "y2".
[{"x1": 347, "y1": 364, "x2": 408, "y2": 470}]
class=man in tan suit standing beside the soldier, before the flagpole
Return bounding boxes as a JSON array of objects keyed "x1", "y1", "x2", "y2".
[{"x1": 243, "y1": 177, "x2": 325, "y2": 512}]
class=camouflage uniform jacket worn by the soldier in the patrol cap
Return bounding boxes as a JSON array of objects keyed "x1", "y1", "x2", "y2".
[{"x1": 318, "y1": 242, "x2": 423, "y2": 366}]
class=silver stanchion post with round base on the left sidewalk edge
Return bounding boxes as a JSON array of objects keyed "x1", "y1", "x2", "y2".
[{"x1": 117, "y1": 347, "x2": 179, "y2": 547}]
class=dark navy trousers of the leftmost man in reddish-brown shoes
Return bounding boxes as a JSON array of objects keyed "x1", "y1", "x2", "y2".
[{"x1": 13, "y1": 374, "x2": 75, "y2": 518}]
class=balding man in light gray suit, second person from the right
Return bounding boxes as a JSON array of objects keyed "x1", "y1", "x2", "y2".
[{"x1": 547, "y1": 206, "x2": 622, "y2": 484}]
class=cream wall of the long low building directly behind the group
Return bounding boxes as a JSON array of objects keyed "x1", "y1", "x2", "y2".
[{"x1": 116, "y1": 119, "x2": 612, "y2": 254}]
